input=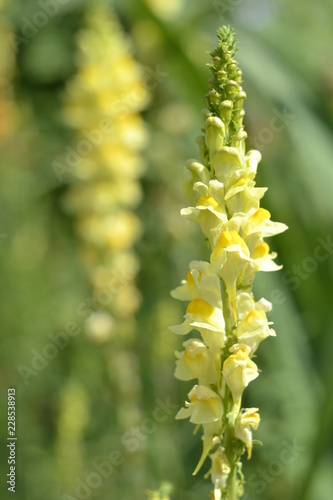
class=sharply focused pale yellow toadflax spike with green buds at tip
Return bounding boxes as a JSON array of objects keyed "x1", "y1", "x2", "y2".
[{"x1": 171, "y1": 26, "x2": 287, "y2": 500}]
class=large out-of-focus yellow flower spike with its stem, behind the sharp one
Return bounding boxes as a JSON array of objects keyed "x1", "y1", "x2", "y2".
[{"x1": 62, "y1": 2, "x2": 149, "y2": 438}]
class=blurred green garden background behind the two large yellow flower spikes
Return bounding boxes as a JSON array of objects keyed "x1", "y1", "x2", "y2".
[{"x1": 0, "y1": 0, "x2": 333, "y2": 500}]
